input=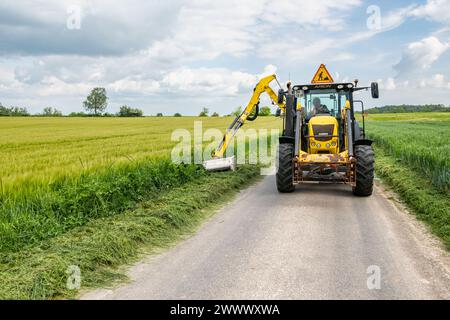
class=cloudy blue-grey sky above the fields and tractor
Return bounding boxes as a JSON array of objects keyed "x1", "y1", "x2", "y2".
[{"x1": 0, "y1": 0, "x2": 450, "y2": 115}]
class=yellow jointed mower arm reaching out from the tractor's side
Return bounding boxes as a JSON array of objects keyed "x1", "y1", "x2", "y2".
[{"x1": 212, "y1": 74, "x2": 286, "y2": 158}]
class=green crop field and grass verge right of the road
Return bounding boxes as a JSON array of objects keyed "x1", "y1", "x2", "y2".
[{"x1": 366, "y1": 113, "x2": 450, "y2": 250}]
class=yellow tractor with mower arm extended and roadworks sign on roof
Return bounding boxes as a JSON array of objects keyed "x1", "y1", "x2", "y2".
[{"x1": 205, "y1": 65, "x2": 379, "y2": 196}]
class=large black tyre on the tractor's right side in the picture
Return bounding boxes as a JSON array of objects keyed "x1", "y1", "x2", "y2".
[{"x1": 353, "y1": 145, "x2": 375, "y2": 197}]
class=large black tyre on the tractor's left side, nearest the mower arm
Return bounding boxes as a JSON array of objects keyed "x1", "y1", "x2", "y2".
[{"x1": 277, "y1": 143, "x2": 295, "y2": 193}]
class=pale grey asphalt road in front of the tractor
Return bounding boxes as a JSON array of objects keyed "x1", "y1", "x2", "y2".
[{"x1": 82, "y1": 176, "x2": 450, "y2": 299}]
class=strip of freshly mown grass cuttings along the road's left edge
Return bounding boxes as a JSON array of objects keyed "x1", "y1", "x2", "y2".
[{"x1": 0, "y1": 166, "x2": 260, "y2": 299}]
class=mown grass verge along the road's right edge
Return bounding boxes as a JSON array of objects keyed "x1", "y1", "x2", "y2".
[{"x1": 375, "y1": 146, "x2": 450, "y2": 250}]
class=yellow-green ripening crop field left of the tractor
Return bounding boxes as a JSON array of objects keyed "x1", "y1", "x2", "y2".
[{"x1": 0, "y1": 117, "x2": 281, "y2": 192}]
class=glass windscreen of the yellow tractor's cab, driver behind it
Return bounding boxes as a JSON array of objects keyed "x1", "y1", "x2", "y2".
[{"x1": 303, "y1": 89, "x2": 349, "y2": 118}]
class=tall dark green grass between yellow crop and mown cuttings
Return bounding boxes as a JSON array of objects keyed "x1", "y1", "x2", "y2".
[{"x1": 0, "y1": 158, "x2": 205, "y2": 251}]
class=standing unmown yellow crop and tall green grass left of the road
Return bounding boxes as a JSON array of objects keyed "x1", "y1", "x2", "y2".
[{"x1": 0, "y1": 117, "x2": 280, "y2": 252}]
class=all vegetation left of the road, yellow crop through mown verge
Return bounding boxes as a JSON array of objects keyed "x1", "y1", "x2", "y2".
[{"x1": 0, "y1": 117, "x2": 280, "y2": 299}]
